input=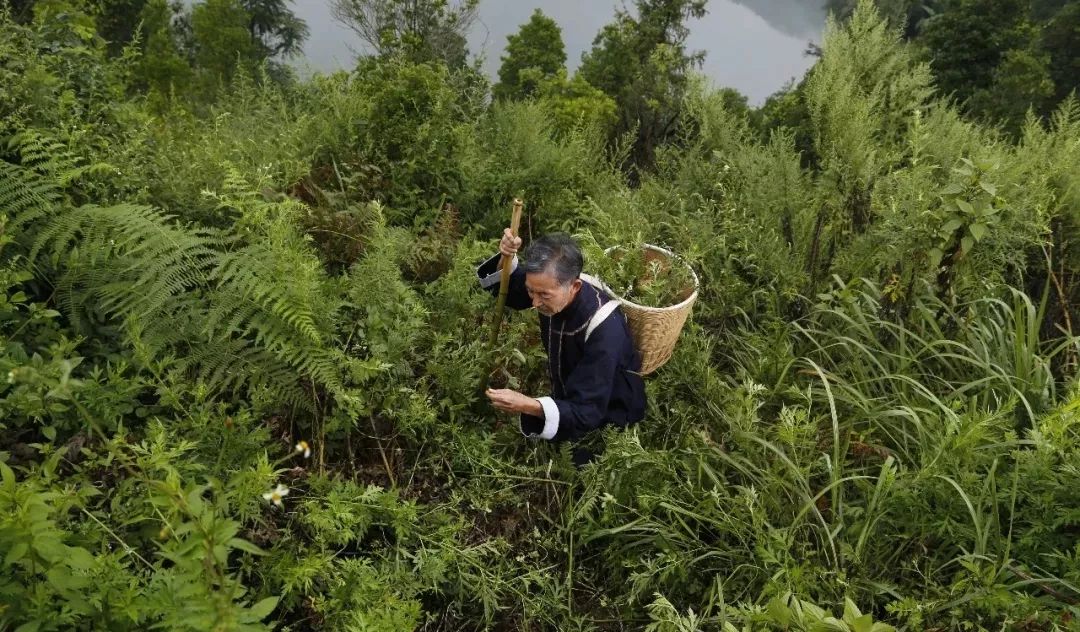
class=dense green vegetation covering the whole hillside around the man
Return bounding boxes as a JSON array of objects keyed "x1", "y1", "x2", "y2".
[{"x1": 0, "y1": 0, "x2": 1080, "y2": 632}]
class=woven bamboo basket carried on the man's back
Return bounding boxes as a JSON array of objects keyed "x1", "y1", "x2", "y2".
[{"x1": 582, "y1": 244, "x2": 699, "y2": 375}]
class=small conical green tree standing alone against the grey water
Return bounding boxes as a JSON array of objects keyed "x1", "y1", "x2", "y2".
[{"x1": 492, "y1": 9, "x2": 566, "y2": 99}]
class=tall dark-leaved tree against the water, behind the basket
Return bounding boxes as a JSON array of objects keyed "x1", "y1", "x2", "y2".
[{"x1": 579, "y1": 0, "x2": 705, "y2": 169}]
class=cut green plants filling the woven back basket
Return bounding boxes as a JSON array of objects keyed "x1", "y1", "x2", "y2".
[{"x1": 578, "y1": 233, "x2": 694, "y2": 307}]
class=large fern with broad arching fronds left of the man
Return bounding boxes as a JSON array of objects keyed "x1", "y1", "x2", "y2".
[{"x1": 0, "y1": 145, "x2": 377, "y2": 411}]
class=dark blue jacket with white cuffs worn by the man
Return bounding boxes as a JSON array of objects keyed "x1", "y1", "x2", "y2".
[{"x1": 476, "y1": 255, "x2": 645, "y2": 440}]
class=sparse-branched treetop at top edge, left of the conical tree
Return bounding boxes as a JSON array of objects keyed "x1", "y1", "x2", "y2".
[{"x1": 332, "y1": 0, "x2": 480, "y2": 67}]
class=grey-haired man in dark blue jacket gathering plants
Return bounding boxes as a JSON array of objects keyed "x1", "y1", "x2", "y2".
[{"x1": 476, "y1": 228, "x2": 645, "y2": 451}]
